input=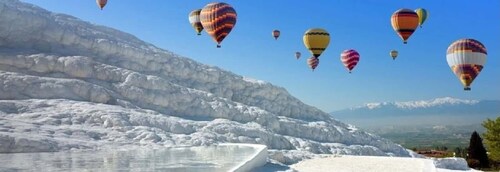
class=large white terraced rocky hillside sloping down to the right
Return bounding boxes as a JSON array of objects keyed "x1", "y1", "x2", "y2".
[{"x1": 0, "y1": 0, "x2": 409, "y2": 163}]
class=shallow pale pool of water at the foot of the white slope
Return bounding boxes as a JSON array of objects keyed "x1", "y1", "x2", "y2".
[{"x1": 0, "y1": 145, "x2": 256, "y2": 172}]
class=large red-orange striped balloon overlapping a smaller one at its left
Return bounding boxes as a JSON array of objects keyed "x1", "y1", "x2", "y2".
[{"x1": 200, "y1": 2, "x2": 236, "y2": 48}]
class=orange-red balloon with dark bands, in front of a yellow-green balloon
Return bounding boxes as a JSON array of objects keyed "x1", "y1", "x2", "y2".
[{"x1": 391, "y1": 9, "x2": 419, "y2": 44}]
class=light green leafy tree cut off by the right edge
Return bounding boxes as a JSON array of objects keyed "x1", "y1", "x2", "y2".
[{"x1": 483, "y1": 117, "x2": 500, "y2": 161}]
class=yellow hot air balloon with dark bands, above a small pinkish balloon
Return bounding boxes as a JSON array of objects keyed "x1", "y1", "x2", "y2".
[{"x1": 303, "y1": 28, "x2": 330, "y2": 57}]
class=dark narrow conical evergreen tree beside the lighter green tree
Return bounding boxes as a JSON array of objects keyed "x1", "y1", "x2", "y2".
[{"x1": 467, "y1": 131, "x2": 489, "y2": 168}]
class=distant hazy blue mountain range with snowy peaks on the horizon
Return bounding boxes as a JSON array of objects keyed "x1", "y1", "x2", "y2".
[{"x1": 331, "y1": 97, "x2": 500, "y2": 126}]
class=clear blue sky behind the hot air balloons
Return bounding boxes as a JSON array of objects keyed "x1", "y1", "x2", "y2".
[{"x1": 21, "y1": 0, "x2": 500, "y2": 112}]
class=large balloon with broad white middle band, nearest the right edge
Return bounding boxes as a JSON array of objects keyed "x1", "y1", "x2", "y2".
[{"x1": 446, "y1": 39, "x2": 487, "y2": 90}]
